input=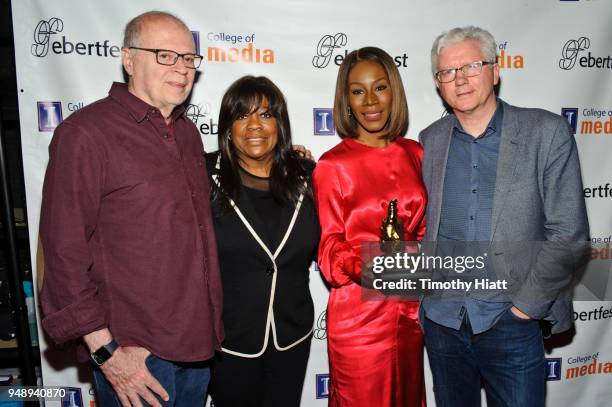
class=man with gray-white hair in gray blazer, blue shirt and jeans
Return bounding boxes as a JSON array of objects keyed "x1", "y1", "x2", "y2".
[{"x1": 420, "y1": 27, "x2": 589, "y2": 407}]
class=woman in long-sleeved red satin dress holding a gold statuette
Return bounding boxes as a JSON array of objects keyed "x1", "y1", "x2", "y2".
[{"x1": 314, "y1": 47, "x2": 427, "y2": 407}]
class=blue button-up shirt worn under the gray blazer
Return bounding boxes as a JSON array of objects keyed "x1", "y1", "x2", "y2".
[{"x1": 423, "y1": 103, "x2": 512, "y2": 334}]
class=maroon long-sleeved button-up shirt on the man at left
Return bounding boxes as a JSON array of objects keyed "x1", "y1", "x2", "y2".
[{"x1": 40, "y1": 83, "x2": 223, "y2": 361}]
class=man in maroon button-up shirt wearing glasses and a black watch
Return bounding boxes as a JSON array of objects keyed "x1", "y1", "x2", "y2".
[{"x1": 40, "y1": 12, "x2": 223, "y2": 406}]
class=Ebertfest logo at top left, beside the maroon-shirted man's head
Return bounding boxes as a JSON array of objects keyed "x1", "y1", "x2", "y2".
[{"x1": 30, "y1": 17, "x2": 121, "y2": 58}]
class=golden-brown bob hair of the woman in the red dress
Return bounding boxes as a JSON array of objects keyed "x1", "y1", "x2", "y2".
[{"x1": 334, "y1": 47, "x2": 408, "y2": 140}]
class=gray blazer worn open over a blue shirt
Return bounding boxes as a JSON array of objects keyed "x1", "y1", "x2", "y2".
[{"x1": 419, "y1": 101, "x2": 589, "y2": 333}]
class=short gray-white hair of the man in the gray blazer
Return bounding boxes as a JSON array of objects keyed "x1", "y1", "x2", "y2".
[{"x1": 431, "y1": 25, "x2": 497, "y2": 75}]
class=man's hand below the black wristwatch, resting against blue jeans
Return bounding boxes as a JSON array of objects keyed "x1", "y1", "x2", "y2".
[{"x1": 100, "y1": 346, "x2": 169, "y2": 407}]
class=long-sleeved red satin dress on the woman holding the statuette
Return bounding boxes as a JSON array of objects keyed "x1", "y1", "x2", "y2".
[{"x1": 314, "y1": 138, "x2": 427, "y2": 407}]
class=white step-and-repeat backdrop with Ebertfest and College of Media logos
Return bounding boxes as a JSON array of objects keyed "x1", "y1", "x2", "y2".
[{"x1": 12, "y1": 0, "x2": 612, "y2": 406}]
